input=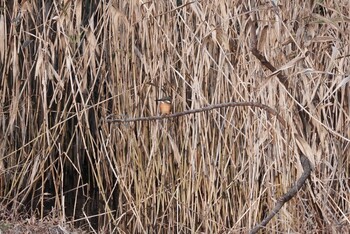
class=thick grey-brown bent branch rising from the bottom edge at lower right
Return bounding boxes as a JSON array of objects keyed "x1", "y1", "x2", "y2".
[{"x1": 249, "y1": 154, "x2": 311, "y2": 234}]
